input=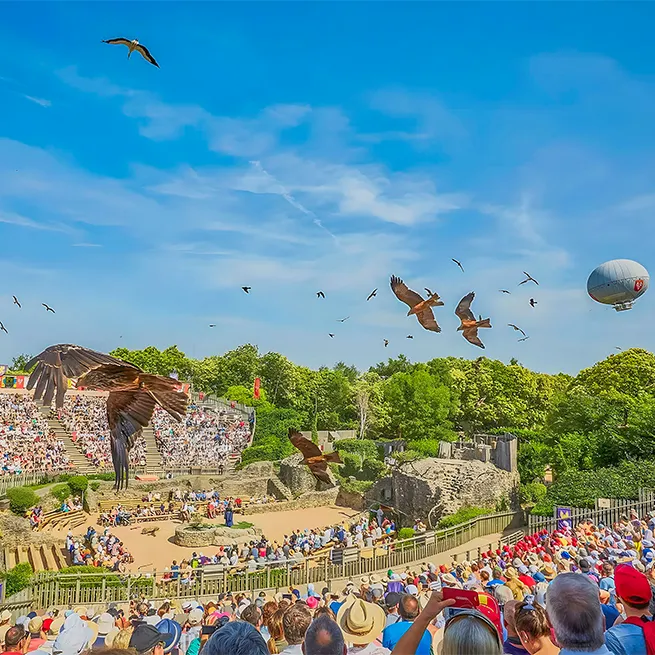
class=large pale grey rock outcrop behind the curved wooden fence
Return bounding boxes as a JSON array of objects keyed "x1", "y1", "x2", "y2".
[{"x1": 367, "y1": 458, "x2": 519, "y2": 524}]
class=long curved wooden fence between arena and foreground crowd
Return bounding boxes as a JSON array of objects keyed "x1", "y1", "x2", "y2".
[{"x1": 1, "y1": 511, "x2": 524, "y2": 611}]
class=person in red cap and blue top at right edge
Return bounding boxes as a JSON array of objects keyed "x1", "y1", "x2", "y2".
[{"x1": 605, "y1": 564, "x2": 655, "y2": 655}]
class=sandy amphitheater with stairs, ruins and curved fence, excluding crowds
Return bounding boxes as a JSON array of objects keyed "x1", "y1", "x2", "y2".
[{"x1": 0, "y1": 389, "x2": 524, "y2": 614}]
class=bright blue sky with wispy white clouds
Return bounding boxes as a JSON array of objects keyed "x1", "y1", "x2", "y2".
[{"x1": 0, "y1": 2, "x2": 655, "y2": 372}]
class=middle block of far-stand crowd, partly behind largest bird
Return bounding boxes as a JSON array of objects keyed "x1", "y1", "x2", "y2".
[{"x1": 57, "y1": 394, "x2": 146, "y2": 467}]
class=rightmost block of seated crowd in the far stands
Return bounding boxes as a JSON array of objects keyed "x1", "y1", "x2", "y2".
[{"x1": 152, "y1": 404, "x2": 250, "y2": 468}]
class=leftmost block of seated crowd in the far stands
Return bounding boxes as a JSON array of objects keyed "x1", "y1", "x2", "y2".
[{"x1": 0, "y1": 393, "x2": 70, "y2": 475}]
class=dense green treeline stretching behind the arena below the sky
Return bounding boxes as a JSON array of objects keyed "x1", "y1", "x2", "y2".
[{"x1": 16, "y1": 344, "x2": 655, "y2": 511}]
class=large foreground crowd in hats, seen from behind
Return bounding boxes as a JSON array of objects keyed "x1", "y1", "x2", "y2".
[{"x1": 6, "y1": 514, "x2": 655, "y2": 655}]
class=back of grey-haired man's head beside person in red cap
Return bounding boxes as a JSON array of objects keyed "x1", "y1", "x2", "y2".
[{"x1": 546, "y1": 573, "x2": 605, "y2": 652}]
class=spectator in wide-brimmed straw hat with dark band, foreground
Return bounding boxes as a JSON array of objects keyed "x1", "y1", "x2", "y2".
[{"x1": 337, "y1": 596, "x2": 390, "y2": 655}]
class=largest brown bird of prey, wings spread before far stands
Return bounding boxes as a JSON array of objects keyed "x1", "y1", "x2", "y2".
[{"x1": 25, "y1": 344, "x2": 189, "y2": 490}]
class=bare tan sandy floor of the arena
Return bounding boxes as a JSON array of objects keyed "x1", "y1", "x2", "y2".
[{"x1": 57, "y1": 506, "x2": 358, "y2": 571}]
